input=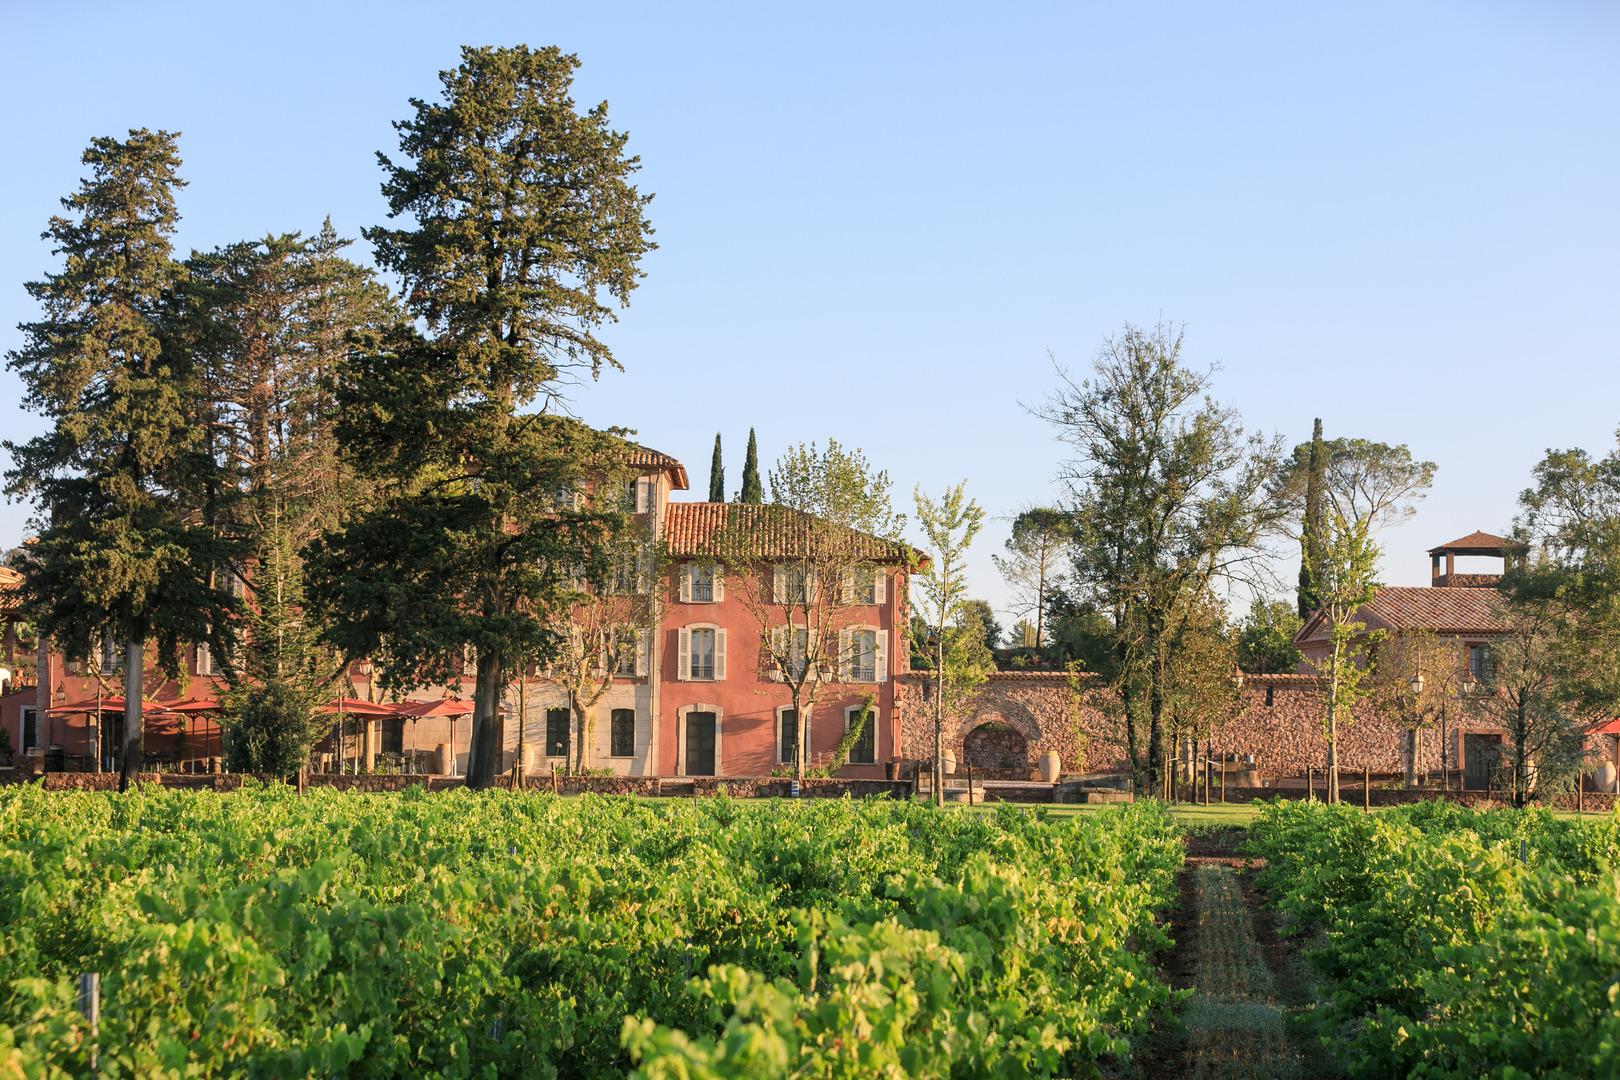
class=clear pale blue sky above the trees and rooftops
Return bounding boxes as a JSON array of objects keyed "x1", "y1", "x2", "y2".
[{"x1": 0, "y1": 0, "x2": 1620, "y2": 625}]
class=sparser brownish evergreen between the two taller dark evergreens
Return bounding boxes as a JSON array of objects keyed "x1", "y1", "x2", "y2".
[{"x1": 186, "y1": 220, "x2": 397, "y2": 774}]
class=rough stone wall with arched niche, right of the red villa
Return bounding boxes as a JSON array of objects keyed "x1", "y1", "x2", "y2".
[{"x1": 896, "y1": 672, "x2": 1456, "y2": 776}]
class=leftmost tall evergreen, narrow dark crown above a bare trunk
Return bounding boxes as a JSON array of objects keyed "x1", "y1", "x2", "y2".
[{"x1": 5, "y1": 130, "x2": 233, "y2": 790}]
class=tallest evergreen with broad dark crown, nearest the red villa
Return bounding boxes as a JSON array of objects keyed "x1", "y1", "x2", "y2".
[{"x1": 309, "y1": 47, "x2": 653, "y2": 787}]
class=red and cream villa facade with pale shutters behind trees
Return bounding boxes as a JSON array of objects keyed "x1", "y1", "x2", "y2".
[{"x1": 0, "y1": 449, "x2": 910, "y2": 777}]
